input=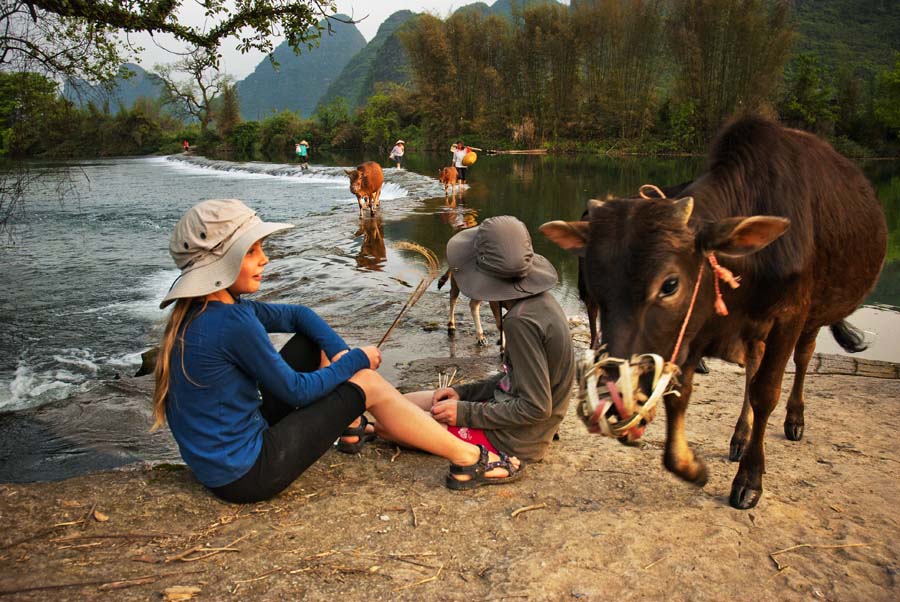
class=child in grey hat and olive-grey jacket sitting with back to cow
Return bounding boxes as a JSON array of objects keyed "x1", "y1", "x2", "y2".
[{"x1": 408, "y1": 215, "x2": 575, "y2": 462}]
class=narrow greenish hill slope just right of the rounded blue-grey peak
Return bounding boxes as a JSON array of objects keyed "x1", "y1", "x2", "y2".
[{"x1": 319, "y1": 10, "x2": 416, "y2": 109}]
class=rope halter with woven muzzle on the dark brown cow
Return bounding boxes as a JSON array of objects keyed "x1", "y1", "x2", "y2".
[{"x1": 576, "y1": 184, "x2": 740, "y2": 443}]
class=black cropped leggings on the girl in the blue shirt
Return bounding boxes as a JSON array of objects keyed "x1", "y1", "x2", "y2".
[{"x1": 211, "y1": 334, "x2": 366, "y2": 503}]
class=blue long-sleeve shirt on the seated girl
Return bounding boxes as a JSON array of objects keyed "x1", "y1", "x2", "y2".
[{"x1": 166, "y1": 301, "x2": 369, "y2": 487}]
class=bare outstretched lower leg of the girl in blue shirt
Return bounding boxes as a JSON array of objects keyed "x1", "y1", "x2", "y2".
[{"x1": 350, "y1": 370, "x2": 519, "y2": 477}]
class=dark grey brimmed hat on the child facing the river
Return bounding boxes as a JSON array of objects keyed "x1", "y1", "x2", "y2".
[{"x1": 447, "y1": 215, "x2": 557, "y2": 301}]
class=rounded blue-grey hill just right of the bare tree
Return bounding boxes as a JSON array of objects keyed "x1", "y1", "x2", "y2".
[{"x1": 237, "y1": 15, "x2": 366, "y2": 120}]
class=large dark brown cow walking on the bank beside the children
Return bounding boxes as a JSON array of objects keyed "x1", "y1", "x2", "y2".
[{"x1": 541, "y1": 118, "x2": 887, "y2": 509}]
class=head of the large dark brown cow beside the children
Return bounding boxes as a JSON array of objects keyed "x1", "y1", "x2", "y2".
[{"x1": 541, "y1": 197, "x2": 789, "y2": 366}]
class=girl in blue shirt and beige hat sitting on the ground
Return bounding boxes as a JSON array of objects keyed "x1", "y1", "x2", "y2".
[{"x1": 153, "y1": 199, "x2": 521, "y2": 503}]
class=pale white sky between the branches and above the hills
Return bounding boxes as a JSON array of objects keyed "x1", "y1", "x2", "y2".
[{"x1": 130, "y1": 0, "x2": 494, "y2": 80}]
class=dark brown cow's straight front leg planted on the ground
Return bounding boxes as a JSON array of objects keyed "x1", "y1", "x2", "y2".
[{"x1": 728, "y1": 324, "x2": 800, "y2": 510}]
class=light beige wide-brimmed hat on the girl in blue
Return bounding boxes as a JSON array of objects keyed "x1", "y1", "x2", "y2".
[{"x1": 159, "y1": 199, "x2": 294, "y2": 309}]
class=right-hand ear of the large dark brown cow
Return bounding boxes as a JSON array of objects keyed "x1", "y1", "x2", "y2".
[{"x1": 698, "y1": 215, "x2": 791, "y2": 257}]
